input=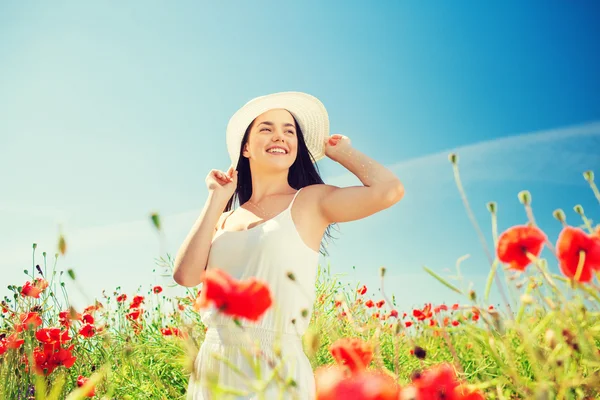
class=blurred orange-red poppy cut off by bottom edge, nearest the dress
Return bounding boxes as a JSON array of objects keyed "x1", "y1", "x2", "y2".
[{"x1": 315, "y1": 366, "x2": 401, "y2": 400}]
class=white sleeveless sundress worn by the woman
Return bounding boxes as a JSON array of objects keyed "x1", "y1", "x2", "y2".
[{"x1": 187, "y1": 190, "x2": 319, "y2": 400}]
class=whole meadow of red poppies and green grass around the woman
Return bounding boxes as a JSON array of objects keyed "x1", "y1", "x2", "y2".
[{"x1": 0, "y1": 155, "x2": 600, "y2": 400}]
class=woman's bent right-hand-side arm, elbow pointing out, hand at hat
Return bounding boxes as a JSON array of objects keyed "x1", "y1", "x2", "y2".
[{"x1": 319, "y1": 135, "x2": 404, "y2": 224}]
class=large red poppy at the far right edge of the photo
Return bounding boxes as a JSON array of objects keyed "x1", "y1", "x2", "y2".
[{"x1": 556, "y1": 226, "x2": 600, "y2": 282}]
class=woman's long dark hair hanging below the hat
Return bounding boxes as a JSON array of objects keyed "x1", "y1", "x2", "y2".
[{"x1": 225, "y1": 112, "x2": 335, "y2": 255}]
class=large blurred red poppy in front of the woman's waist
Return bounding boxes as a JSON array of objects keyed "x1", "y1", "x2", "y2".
[{"x1": 199, "y1": 269, "x2": 273, "y2": 321}]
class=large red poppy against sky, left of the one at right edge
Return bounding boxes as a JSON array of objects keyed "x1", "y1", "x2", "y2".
[{"x1": 496, "y1": 225, "x2": 547, "y2": 271}]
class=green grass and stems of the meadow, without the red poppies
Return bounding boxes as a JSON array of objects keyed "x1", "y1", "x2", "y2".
[{"x1": 0, "y1": 158, "x2": 600, "y2": 399}]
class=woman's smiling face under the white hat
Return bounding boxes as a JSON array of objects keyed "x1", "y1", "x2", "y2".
[{"x1": 242, "y1": 109, "x2": 298, "y2": 169}]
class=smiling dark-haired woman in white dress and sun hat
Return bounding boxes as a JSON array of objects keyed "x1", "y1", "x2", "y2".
[{"x1": 173, "y1": 92, "x2": 404, "y2": 400}]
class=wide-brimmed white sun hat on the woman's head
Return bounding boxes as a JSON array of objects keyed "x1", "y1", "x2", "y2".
[{"x1": 226, "y1": 92, "x2": 329, "y2": 168}]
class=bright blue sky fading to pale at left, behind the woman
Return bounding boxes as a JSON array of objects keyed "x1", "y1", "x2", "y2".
[{"x1": 0, "y1": 1, "x2": 600, "y2": 309}]
